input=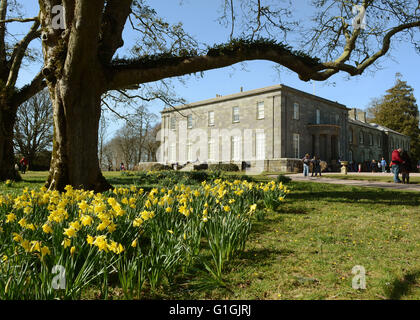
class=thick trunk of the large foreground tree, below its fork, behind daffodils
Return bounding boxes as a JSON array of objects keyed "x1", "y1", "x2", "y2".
[{"x1": 47, "y1": 78, "x2": 111, "y2": 192}]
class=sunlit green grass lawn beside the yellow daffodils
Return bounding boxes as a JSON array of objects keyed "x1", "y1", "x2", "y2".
[{"x1": 0, "y1": 172, "x2": 420, "y2": 299}]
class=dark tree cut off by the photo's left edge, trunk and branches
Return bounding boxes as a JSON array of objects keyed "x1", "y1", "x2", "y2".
[{"x1": 0, "y1": 0, "x2": 46, "y2": 181}]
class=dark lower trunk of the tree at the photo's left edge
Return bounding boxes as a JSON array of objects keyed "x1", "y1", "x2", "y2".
[{"x1": 0, "y1": 99, "x2": 22, "y2": 181}]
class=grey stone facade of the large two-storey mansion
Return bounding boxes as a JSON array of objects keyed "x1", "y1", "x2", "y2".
[{"x1": 159, "y1": 85, "x2": 408, "y2": 172}]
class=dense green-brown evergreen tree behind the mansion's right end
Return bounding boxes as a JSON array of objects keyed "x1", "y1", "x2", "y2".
[{"x1": 368, "y1": 76, "x2": 420, "y2": 159}]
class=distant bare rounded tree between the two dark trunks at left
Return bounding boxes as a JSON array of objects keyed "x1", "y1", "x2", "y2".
[{"x1": 14, "y1": 90, "x2": 53, "y2": 164}]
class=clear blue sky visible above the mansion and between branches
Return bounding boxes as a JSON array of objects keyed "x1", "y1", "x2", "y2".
[{"x1": 9, "y1": 0, "x2": 420, "y2": 139}]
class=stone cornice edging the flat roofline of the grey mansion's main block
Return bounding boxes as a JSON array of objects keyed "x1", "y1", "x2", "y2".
[{"x1": 160, "y1": 84, "x2": 348, "y2": 113}]
